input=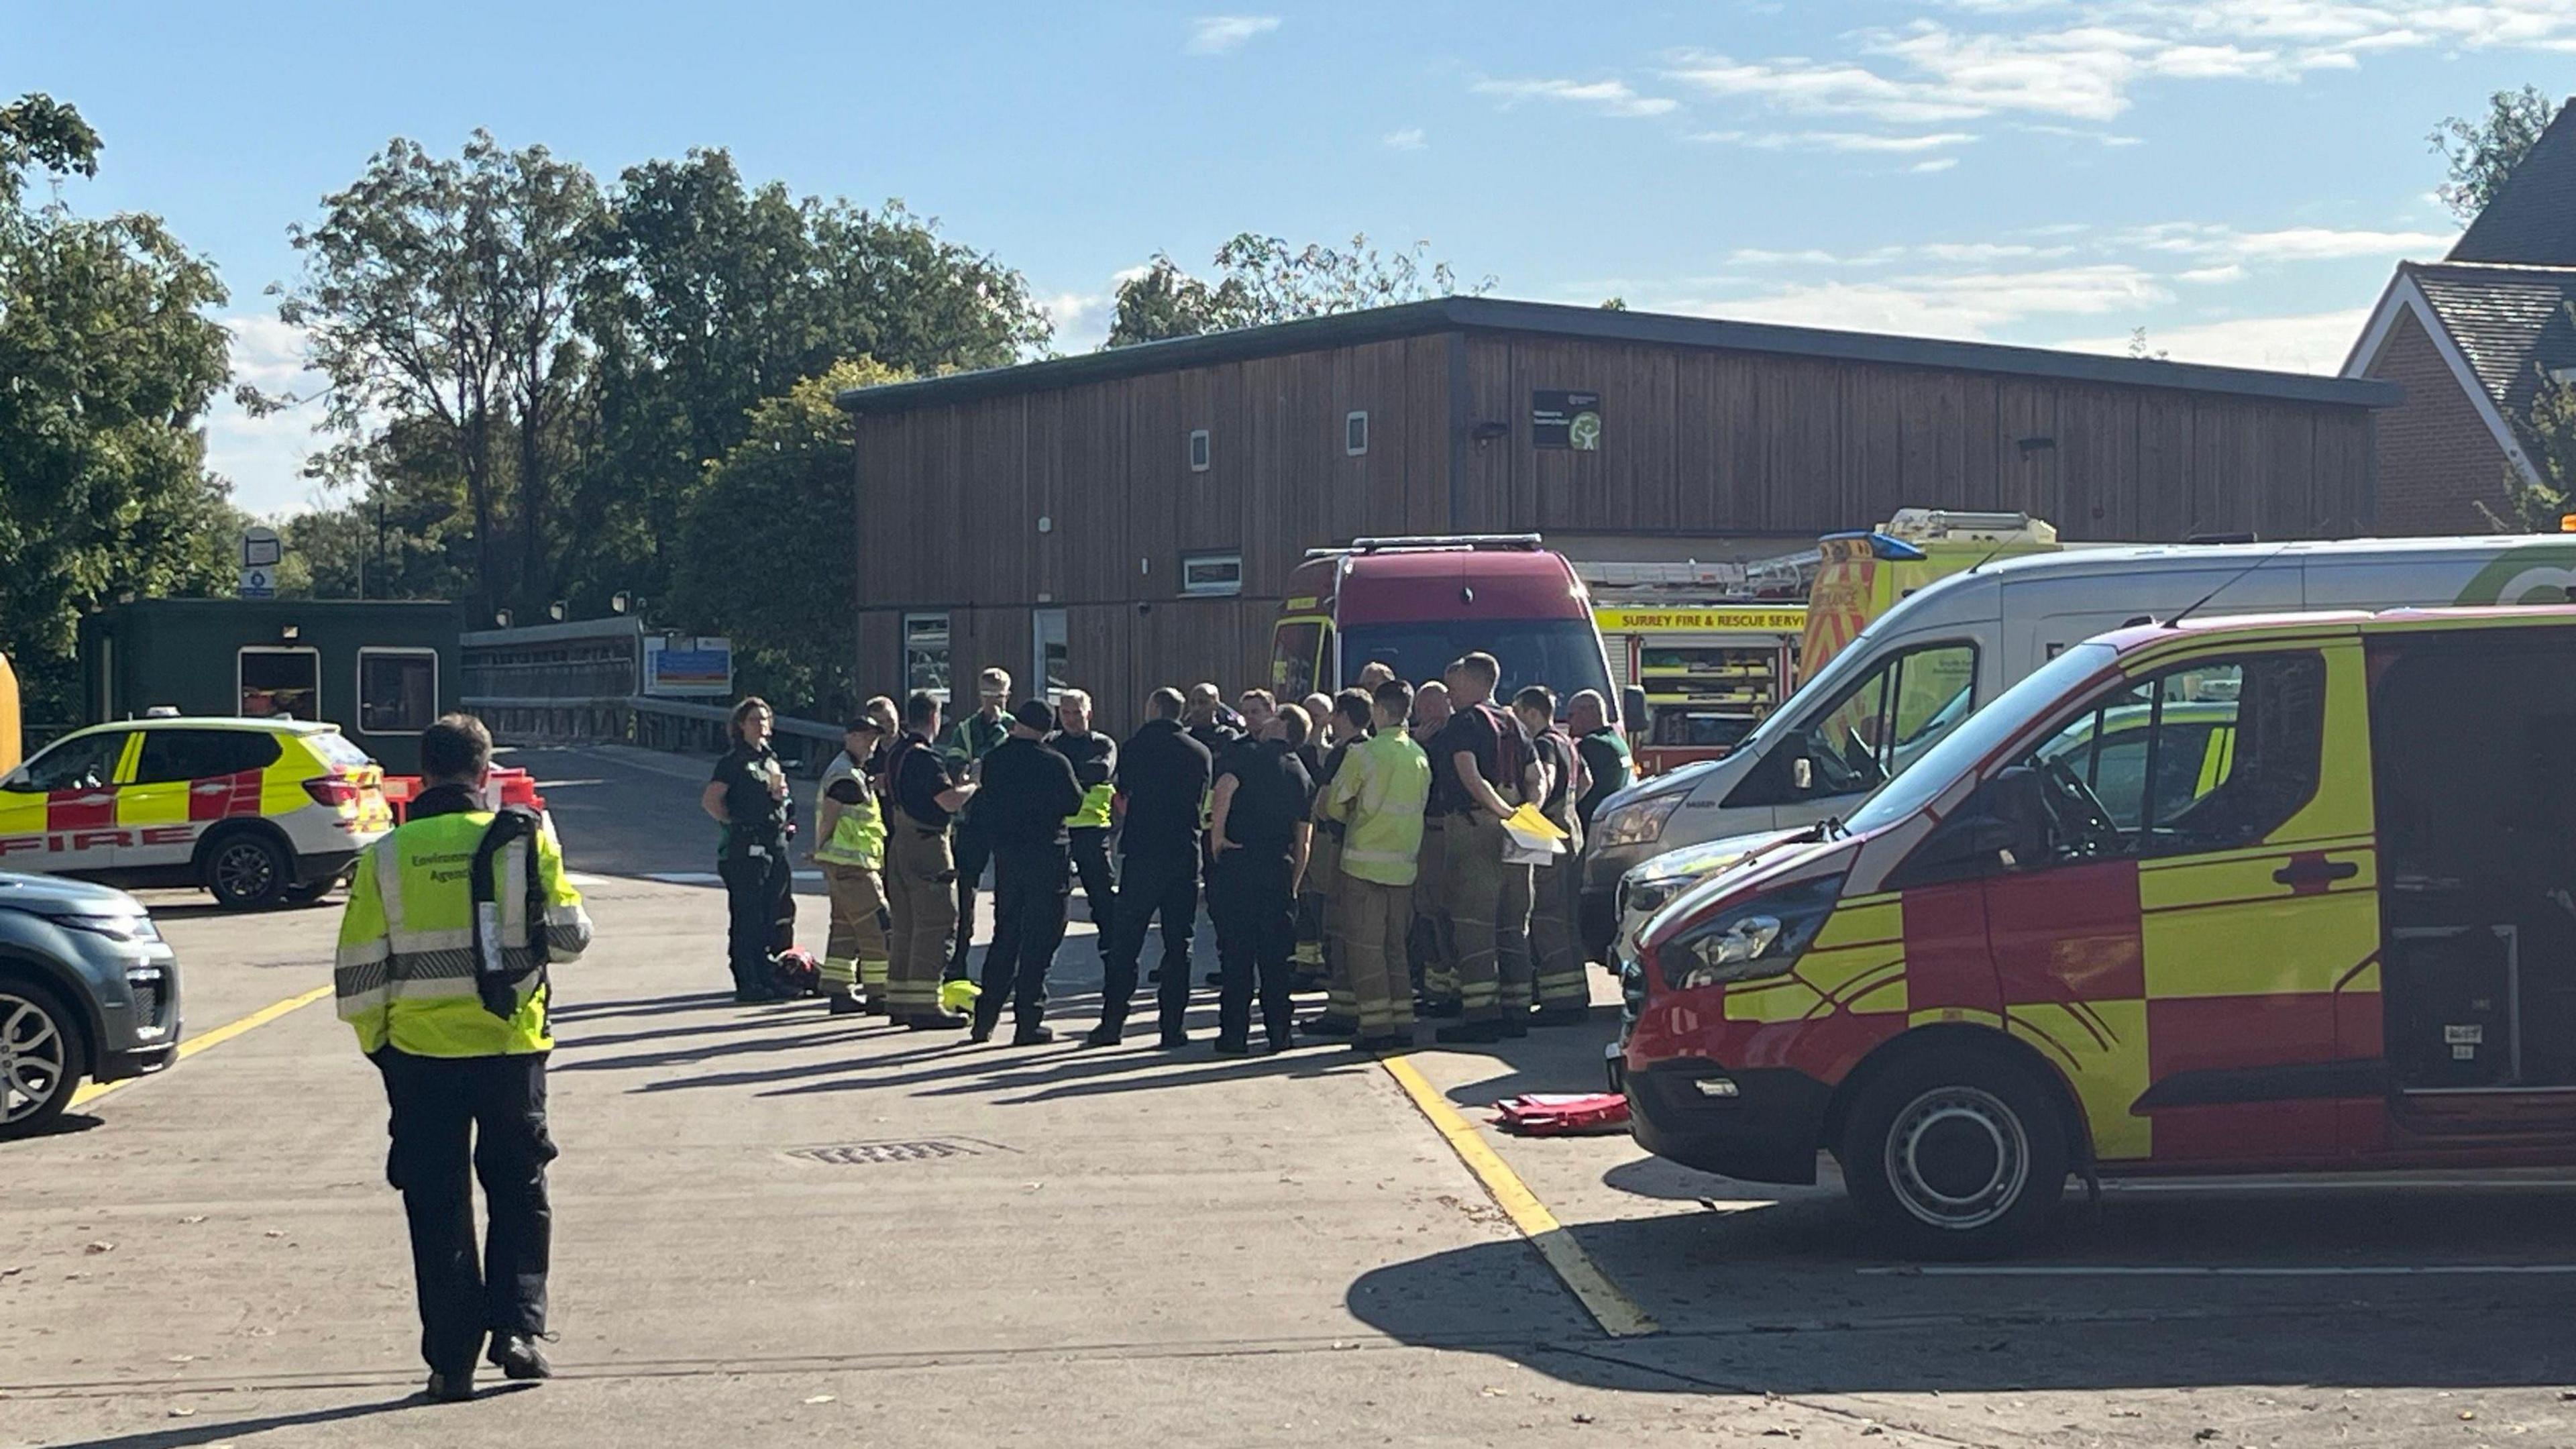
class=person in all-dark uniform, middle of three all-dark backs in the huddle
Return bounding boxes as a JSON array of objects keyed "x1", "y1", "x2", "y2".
[{"x1": 1085, "y1": 688, "x2": 1211, "y2": 1049}]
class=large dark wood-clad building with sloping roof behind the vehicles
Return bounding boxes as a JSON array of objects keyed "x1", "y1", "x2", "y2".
[{"x1": 840, "y1": 297, "x2": 2398, "y2": 727}]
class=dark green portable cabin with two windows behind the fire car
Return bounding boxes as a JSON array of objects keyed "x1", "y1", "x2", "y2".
[{"x1": 80, "y1": 598, "x2": 464, "y2": 773}]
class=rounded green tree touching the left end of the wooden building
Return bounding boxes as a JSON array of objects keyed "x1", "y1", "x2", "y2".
[{"x1": 678, "y1": 358, "x2": 904, "y2": 719}]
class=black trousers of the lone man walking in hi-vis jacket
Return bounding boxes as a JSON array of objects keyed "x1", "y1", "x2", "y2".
[{"x1": 376, "y1": 1046, "x2": 554, "y2": 1375}]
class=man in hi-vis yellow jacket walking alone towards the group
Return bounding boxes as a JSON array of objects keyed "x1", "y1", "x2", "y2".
[{"x1": 332, "y1": 714, "x2": 590, "y2": 1403}]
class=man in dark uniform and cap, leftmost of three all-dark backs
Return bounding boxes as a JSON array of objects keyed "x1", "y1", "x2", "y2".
[{"x1": 974, "y1": 699, "x2": 1082, "y2": 1046}]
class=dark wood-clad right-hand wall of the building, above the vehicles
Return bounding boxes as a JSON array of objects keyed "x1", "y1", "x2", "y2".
[{"x1": 1460, "y1": 335, "x2": 2370, "y2": 541}]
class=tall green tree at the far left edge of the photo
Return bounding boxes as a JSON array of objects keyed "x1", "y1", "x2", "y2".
[{"x1": 0, "y1": 95, "x2": 239, "y2": 719}]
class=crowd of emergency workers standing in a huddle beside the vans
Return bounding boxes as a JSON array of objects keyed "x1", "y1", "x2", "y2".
[{"x1": 747, "y1": 655, "x2": 1628, "y2": 1055}]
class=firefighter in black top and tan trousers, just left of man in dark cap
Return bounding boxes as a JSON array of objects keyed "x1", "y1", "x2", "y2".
[{"x1": 886, "y1": 694, "x2": 974, "y2": 1031}]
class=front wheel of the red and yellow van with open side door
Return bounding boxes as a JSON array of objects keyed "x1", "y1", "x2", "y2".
[{"x1": 1834, "y1": 1049, "x2": 2066, "y2": 1258}]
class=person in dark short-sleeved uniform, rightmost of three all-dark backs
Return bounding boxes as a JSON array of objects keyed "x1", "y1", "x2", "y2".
[{"x1": 1208, "y1": 696, "x2": 1313, "y2": 1057}]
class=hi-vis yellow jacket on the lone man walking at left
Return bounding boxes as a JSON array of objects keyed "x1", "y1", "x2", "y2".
[{"x1": 332, "y1": 794, "x2": 590, "y2": 1057}]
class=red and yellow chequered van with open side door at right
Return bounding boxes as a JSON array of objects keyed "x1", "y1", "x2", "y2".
[{"x1": 1620, "y1": 606, "x2": 2576, "y2": 1253}]
